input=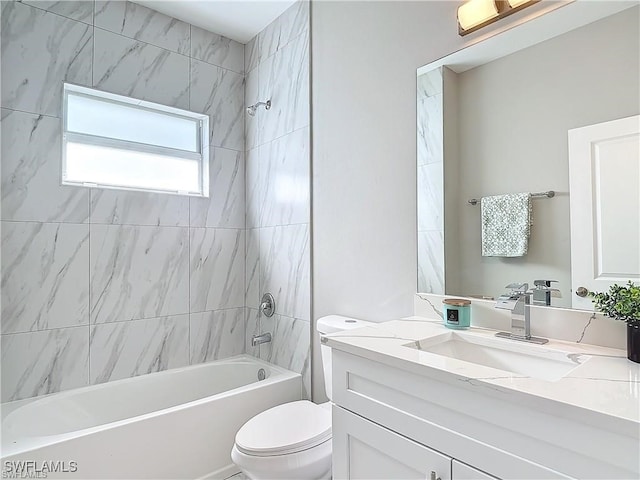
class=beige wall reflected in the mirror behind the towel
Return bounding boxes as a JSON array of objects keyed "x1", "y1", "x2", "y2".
[{"x1": 445, "y1": 8, "x2": 640, "y2": 306}]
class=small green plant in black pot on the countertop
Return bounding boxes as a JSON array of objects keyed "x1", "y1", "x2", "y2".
[{"x1": 589, "y1": 281, "x2": 640, "y2": 363}]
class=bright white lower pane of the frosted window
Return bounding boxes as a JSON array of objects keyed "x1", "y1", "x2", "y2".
[{"x1": 66, "y1": 142, "x2": 200, "y2": 192}]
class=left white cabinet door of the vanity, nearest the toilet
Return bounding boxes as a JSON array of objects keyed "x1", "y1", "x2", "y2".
[{"x1": 333, "y1": 405, "x2": 451, "y2": 480}]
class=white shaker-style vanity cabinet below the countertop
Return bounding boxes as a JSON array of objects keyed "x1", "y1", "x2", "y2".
[{"x1": 332, "y1": 348, "x2": 637, "y2": 480}]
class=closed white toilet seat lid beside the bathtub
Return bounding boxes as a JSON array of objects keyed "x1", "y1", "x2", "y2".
[{"x1": 236, "y1": 400, "x2": 331, "y2": 457}]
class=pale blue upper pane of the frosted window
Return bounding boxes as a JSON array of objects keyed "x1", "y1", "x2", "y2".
[{"x1": 67, "y1": 93, "x2": 199, "y2": 152}]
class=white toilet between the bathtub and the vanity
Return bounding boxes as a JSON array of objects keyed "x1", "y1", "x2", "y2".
[{"x1": 231, "y1": 315, "x2": 372, "y2": 480}]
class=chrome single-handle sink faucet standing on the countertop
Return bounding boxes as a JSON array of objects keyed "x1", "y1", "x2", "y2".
[{"x1": 495, "y1": 283, "x2": 549, "y2": 345}]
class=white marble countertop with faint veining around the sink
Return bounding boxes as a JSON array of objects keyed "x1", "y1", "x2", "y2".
[{"x1": 322, "y1": 317, "x2": 640, "y2": 437}]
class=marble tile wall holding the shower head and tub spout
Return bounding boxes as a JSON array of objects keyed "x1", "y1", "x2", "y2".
[{"x1": 245, "y1": 1, "x2": 311, "y2": 397}]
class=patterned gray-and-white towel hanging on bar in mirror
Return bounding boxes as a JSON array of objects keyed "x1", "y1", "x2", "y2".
[{"x1": 480, "y1": 193, "x2": 531, "y2": 257}]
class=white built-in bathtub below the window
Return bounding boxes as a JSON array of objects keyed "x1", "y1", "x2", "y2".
[{"x1": 2, "y1": 355, "x2": 302, "y2": 480}]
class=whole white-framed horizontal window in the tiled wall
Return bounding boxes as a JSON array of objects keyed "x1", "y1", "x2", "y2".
[{"x1": 62, "y1": 83, "x2": 209, "y2": 197}]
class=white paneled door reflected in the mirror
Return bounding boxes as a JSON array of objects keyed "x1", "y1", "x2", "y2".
[{"x1": 569, "y1": 115, "x2": 640, "y2": 310}]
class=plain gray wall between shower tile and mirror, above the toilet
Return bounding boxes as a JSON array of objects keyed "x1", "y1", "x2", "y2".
[{"x1": 311, "y1": 1, "x2": 568, "y2": 400}]
